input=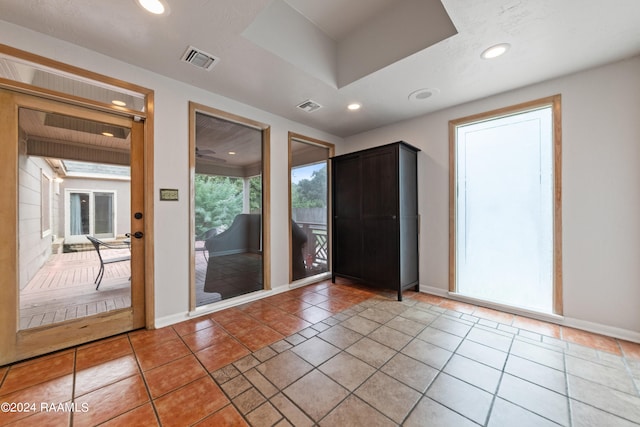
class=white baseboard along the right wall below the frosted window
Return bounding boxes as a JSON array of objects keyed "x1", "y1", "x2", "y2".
[{"x1": 420, "y1": 285, "x2": 640, "y2": 343}]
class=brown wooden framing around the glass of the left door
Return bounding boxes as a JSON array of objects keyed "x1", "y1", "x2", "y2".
[{"x1": 0, "y1": 44, "x2": 155, "y2": 365}]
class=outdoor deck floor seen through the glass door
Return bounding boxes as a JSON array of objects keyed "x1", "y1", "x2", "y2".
[{"x1": 20, "y1": 249, "x2": 131, "y2": 329}]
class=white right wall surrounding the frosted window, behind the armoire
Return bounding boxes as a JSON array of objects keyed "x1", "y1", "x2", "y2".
[{"x1": 344, "y1": 57, "x2": 640, "y2": 340}]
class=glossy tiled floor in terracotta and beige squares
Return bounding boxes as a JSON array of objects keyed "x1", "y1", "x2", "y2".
[{"x1": 0, "y1": 282, "x2": 640, "y2": 427}]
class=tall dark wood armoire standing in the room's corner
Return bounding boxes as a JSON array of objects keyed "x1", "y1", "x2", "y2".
[{"x1": 331, "y1": 141, "x2": 420, "y2": 301}]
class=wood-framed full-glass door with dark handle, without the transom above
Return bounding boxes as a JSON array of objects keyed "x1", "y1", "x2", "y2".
[{"x1": 0, "y1": 90, "x2": 144, "y2": 364}]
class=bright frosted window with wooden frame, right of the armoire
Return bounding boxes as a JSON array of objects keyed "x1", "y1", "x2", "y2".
[{"x1": 450, "y1": 96, "x2": 562, "y2": 313}]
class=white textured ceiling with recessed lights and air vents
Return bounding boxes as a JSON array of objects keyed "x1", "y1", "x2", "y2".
[{"x1": 0, "y1": 0, "x2": 640, "y2": 137}]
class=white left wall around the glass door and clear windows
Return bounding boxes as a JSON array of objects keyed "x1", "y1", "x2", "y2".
[{"x1": 0, "y1": 21, "x2": 342, "y2": 325}]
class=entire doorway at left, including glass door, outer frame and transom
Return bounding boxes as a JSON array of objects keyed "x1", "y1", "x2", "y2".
[{"x1": 0, "y1": 44, "x2": 153, "y2": 364}]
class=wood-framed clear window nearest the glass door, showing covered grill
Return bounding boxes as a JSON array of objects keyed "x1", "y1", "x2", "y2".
[{"x1": 189, "y1": 103, "x2": 269, "y2": 310}]
